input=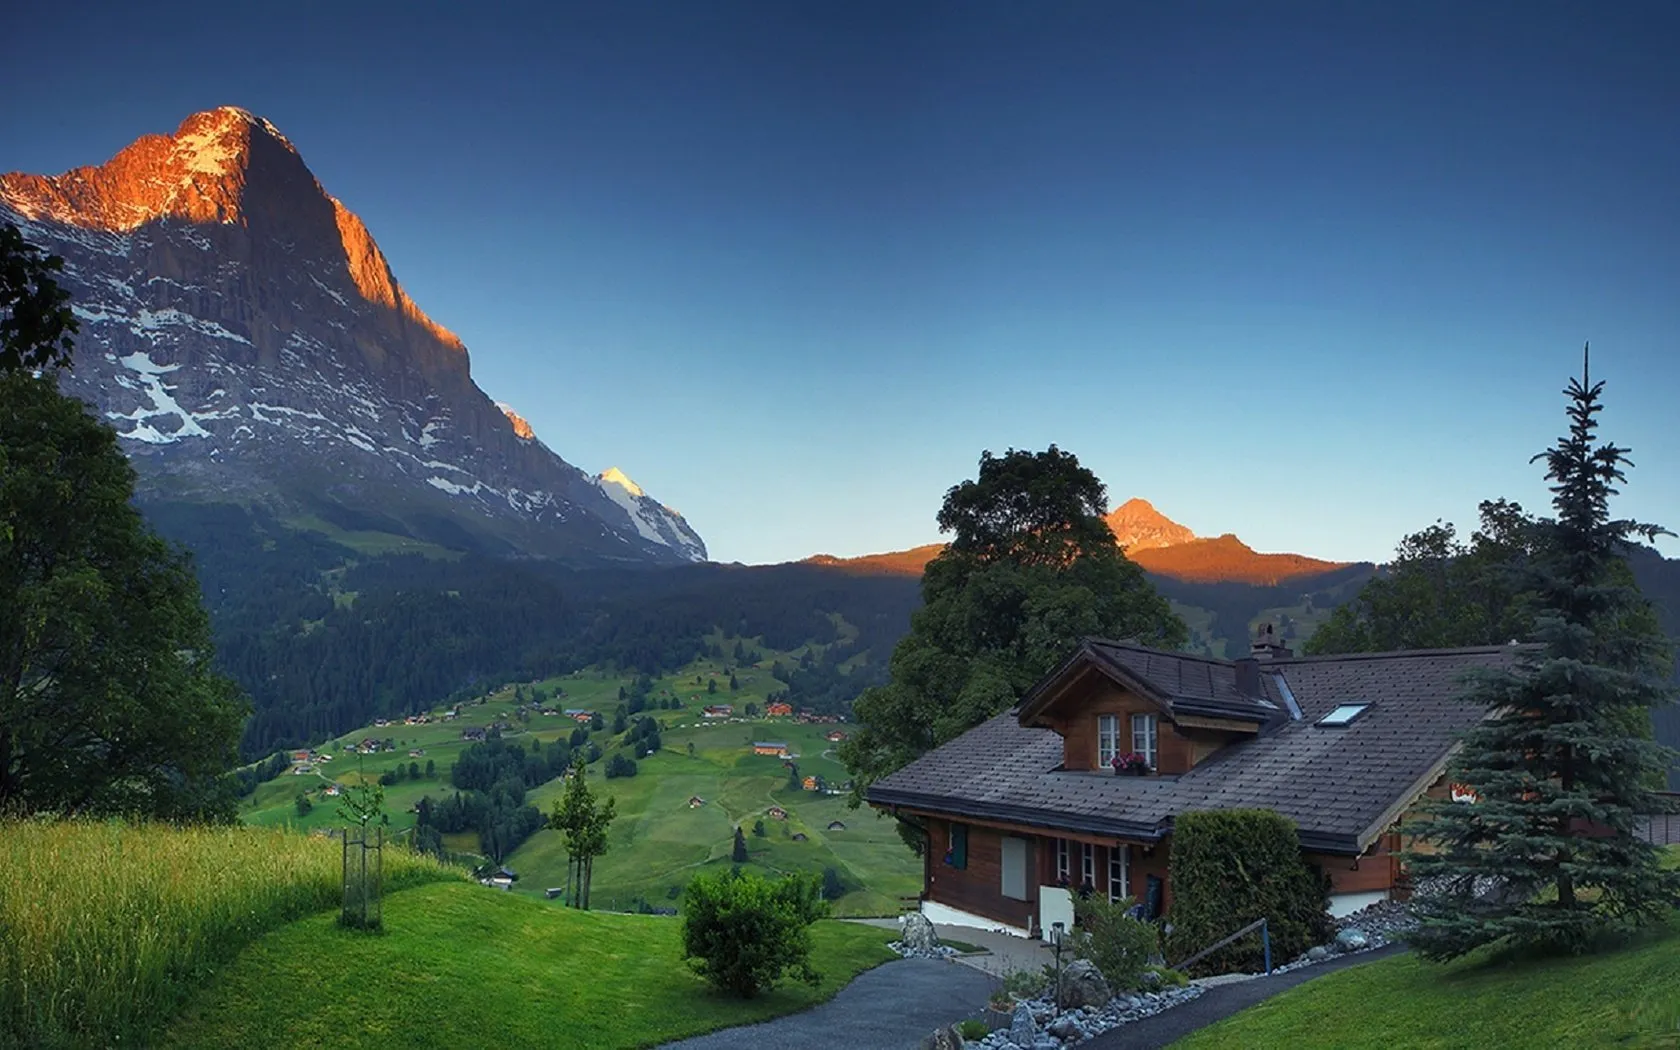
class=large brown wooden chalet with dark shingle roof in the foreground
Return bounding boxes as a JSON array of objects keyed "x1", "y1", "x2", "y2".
[{"x1": 867, "y1": 628, "x2": 1520, "y2": 936}]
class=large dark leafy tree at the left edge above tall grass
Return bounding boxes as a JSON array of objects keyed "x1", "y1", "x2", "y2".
[{"x1": 0, "y1": 227, "x2": 245, "y2": 820}]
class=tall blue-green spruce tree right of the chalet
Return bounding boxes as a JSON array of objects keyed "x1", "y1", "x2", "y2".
[{"x1": 1408, "y1": 349, "x2": 1680, "y2": 959}]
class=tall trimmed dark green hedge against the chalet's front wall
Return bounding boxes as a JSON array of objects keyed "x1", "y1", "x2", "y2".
[{"x1": 1168, "y1": 810, "x2": 1334, "y2": 976}]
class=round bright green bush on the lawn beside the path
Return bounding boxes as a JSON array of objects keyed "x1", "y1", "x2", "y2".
[{"x1": 682, "y1": 872, "x2": 828, "y2": 1000}]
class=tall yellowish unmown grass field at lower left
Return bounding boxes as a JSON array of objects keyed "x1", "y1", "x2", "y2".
[{"x1": 0, "y1": 820, "x2": 462, "y2": 1050}]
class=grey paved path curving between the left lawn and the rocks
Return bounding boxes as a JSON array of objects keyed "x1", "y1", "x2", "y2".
[{"x1": 660, "y1": 959, "x2": 998, "y2": 1050}]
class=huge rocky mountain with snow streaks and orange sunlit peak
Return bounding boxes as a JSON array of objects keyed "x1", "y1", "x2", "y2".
[{"x1": 0, "y1": 108, "x2": 706, "y2": 563}]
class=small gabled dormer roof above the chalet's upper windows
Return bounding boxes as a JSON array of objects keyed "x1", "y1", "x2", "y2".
[{"x1": 1020, "y1": 638, "x2": 1284, "y2": 724}]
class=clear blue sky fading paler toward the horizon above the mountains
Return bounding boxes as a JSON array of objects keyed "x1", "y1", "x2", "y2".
[{"x1": 0, "y1": 0, "x2": 1680, "y2": 563}]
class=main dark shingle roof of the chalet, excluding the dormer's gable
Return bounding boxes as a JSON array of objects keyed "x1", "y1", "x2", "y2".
[{"x1": 869, "y1": 643, "x2": 1519, "y2": 853}]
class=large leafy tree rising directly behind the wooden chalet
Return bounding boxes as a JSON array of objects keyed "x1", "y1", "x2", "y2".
[{"x1": 840, "y1": 445, "x2": 1186, "y2": 819}]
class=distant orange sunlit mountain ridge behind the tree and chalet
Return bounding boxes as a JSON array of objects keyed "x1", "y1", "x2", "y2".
[{"x1": 806, "y1": 499, "x2": 1359, "y2": 586}]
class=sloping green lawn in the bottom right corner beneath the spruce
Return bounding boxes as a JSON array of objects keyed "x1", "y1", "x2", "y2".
[{"x1": 1173, "y1": 916, "x2": 1680, "y2": 1050}]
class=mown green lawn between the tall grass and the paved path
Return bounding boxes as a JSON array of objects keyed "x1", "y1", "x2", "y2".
[{"x1": 160, "y1": 882, "x2": 894, "y2": 1050}]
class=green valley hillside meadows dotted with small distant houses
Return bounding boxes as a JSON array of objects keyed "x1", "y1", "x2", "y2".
[{"x1": 242, "y1": 637, "x2": 921, "y2": 916}]
